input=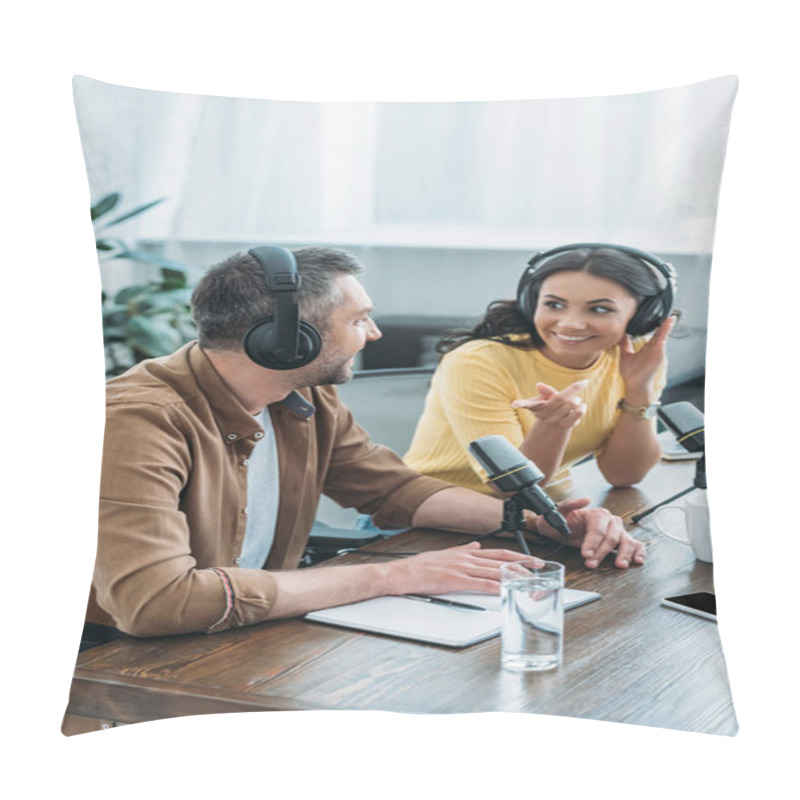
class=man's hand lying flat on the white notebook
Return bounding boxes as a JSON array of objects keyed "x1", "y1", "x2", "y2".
[{"x1": 384, "y1": 542, "x2": 540, "y2": 594}]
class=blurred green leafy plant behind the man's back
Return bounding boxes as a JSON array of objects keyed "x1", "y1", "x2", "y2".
[{"x1": 91, "y1": 192, "x2": 197, "y2": 378}]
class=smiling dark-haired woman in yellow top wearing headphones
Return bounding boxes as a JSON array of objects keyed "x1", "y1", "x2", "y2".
[{"x1": 405, "y1": 244, "x2": 675, "y2": 492}]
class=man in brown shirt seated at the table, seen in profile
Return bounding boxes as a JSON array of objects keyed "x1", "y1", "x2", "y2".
[{"x1": 87, "y1": 248, "x2": 644, "y2": 636}]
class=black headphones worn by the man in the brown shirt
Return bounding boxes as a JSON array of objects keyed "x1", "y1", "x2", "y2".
[{"x1": 242, "y1": 245, "x2": 322, "y2": 370}]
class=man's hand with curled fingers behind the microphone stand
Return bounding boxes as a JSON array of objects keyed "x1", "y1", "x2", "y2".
[{"x1": 536, "y1": 498, "x2": 645, "y2": 569}]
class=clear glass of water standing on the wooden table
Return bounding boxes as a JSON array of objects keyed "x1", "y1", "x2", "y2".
[{"x1": 500, "y1": 560, "x2": 564, "y2": 672}]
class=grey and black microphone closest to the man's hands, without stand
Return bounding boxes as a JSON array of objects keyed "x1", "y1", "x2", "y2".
[{"x1": 469, "y1": 435, "x2": 570, "y2": 537}]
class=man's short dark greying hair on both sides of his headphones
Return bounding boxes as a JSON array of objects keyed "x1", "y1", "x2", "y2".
[{"x1": 191, "y1": 247, "x2": 364, "y2": 350}]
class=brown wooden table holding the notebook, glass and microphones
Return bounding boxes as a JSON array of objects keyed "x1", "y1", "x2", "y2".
[{"x1": 62, "y1": 456, "x2": 737, "y2": 735}]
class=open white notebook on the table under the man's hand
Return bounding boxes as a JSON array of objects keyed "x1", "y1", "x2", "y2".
[{"x1": 305, "y1": 589, "x2": 600, "y2": 647}]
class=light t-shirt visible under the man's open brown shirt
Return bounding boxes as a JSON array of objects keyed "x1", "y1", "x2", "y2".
[{"x1": 237, "y1": 408, "x2": 280, "y2": 569}]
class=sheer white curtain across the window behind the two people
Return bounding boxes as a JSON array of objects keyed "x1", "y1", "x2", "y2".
[{"x1": 75, "y1": 78, "x2": 732, "y2": 253}]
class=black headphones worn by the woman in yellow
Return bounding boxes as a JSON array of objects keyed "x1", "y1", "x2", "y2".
[{"x1": 517, "y1": 243, "x2": 677, "y2": 336}]
